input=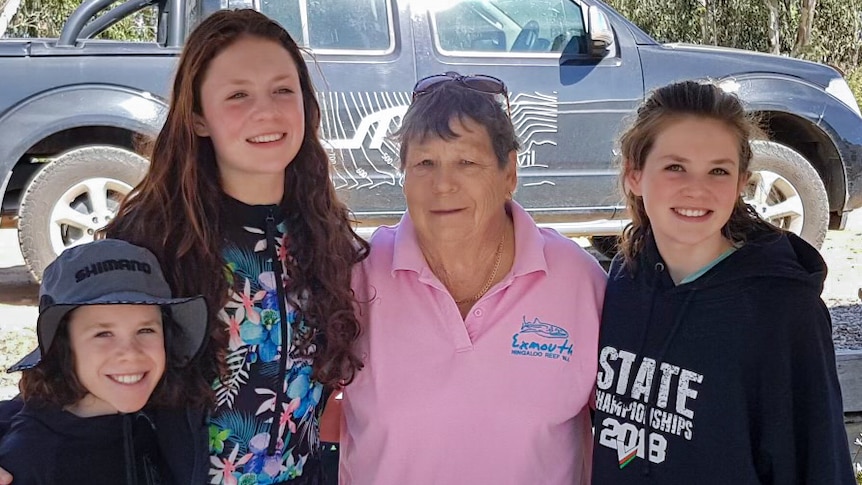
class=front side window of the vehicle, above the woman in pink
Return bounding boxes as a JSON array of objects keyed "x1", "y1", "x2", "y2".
[{"x1": 432, "y1": 0, "x2": 586, "y2": 53}]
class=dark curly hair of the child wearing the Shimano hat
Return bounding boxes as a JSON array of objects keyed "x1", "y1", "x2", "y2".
[{"x1": 18, "y1": 307, "x2": 212, "y2": 408}]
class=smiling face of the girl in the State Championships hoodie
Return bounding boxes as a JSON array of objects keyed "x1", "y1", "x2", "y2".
[{"x1": 625, "y1": 116, "x2": 745, "y2": 262}]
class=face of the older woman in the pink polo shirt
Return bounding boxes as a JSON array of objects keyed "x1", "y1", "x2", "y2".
[{"x1": 404, "y1": 118, "x2": 517, "y2": 242}]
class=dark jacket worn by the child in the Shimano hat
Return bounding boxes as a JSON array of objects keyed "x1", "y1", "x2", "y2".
[{"x1": 0, "y1": 398, "x2": 209, "y2": 485}]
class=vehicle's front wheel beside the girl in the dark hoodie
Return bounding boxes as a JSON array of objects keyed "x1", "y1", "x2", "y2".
[{"x1": 743, "y1": 141, "x2": 829, "y2": 249}]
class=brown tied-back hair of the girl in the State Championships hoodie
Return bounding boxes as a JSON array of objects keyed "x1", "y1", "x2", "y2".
[{"x1": 619, "y1": 81, "x2": 779, "y2": 268}]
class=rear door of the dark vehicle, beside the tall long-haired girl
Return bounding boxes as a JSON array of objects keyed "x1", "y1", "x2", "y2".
[{"x1": 259, "y1": 0, "x2": 416, "y2": 229}]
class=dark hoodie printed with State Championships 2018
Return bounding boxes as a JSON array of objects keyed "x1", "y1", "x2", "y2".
[{"x1": 593, "y1": 233, "x2": 855, "y2": 485}]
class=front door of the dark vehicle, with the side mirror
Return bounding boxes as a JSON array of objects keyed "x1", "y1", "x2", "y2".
[{"x1": 413, "y1": 0, "x2": 643, "y2": 222}]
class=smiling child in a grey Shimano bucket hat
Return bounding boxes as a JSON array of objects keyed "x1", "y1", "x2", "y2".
[{"x1": 0, "y1": 239, "x2": 207, "y2": 485}]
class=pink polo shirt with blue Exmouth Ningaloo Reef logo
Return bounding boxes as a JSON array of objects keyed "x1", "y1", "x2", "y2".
[{"x1": 340, "y1": 203, "x2": 606, "y2": 485}]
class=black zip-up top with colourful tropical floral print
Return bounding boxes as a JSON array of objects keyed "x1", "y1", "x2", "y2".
[{"x1": 209, "y1": 198, "x2": 325, "y2": 485}]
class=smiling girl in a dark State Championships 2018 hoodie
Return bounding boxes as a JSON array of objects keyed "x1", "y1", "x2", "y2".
[{"x1": 593, "y1": 81, "x2": 855, "y2": 485}]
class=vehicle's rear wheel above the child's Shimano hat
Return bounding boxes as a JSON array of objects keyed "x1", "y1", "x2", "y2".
[{"x1": 18, "y1": 146, "x2": 149, "y2": 281}]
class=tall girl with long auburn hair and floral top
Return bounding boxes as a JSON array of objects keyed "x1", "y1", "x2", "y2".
[{"x1": 96, "y1": 10, "x2": 368, "y2": 484}]
